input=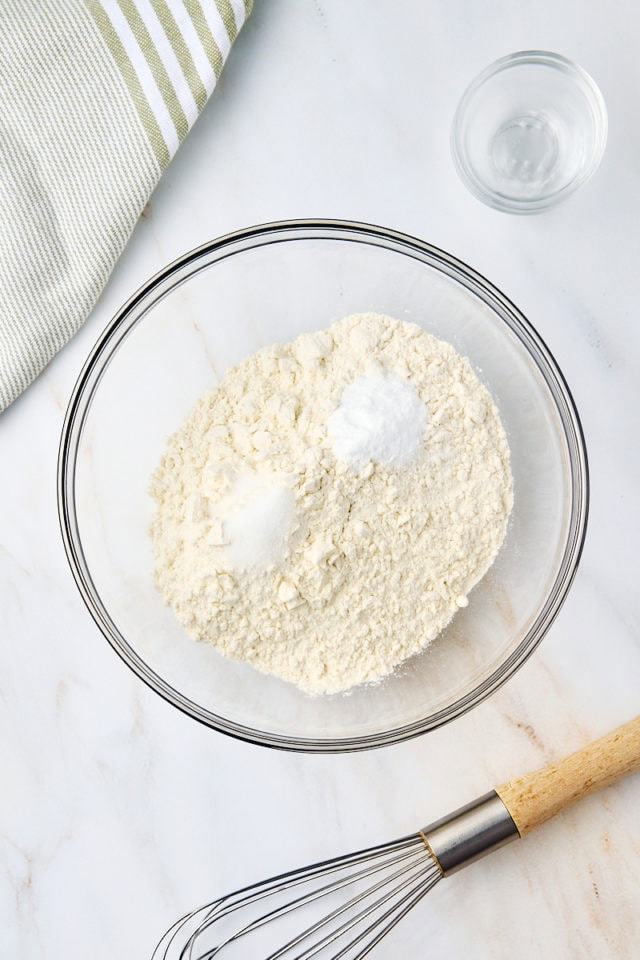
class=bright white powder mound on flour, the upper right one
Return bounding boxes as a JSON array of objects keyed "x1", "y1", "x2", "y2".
[{"x1": 327, "y1": 374, "x2": 427, "y2": 468}]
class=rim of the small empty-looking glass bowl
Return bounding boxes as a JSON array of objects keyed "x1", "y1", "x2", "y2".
[{"x1": 450, "y1": 50, "x2": 609, "y2": 215}]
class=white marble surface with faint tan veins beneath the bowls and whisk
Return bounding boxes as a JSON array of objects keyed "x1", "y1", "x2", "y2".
[{"x1": 0, "y1": 0, "x2": 640, "y2": 960}]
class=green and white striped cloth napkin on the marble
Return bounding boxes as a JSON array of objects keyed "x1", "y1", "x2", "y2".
[{"x1": 0, "y1": 0, "x2": 252, "y2": 410}]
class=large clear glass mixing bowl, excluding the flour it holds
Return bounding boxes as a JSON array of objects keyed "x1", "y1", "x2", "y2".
[{"x1": 58, "y1": 221, "x2": 588, "y2": 752}]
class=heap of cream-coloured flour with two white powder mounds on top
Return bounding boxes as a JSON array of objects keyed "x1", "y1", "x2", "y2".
[{"x1": 152, "y1": 314, "x2": 512, "y2": 693}]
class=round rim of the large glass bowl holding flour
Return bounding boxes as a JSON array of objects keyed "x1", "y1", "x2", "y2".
[{"x1": 57, "y1": 219, "x2": 589, "y2": 753}]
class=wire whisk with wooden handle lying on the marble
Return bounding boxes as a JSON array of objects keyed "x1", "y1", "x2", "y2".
[{"x1": 152, "y1": 716, "x2": 640, "y2": 960}]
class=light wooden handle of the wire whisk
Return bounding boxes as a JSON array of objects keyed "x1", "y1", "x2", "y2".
[{"x1": 496, "y1": 716, "x2": 640, "y2": 837}]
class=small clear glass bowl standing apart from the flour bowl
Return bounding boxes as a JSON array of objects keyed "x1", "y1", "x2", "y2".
[{"x1": 451, "y1": 50, "x2": 607, "y2": 213}]
